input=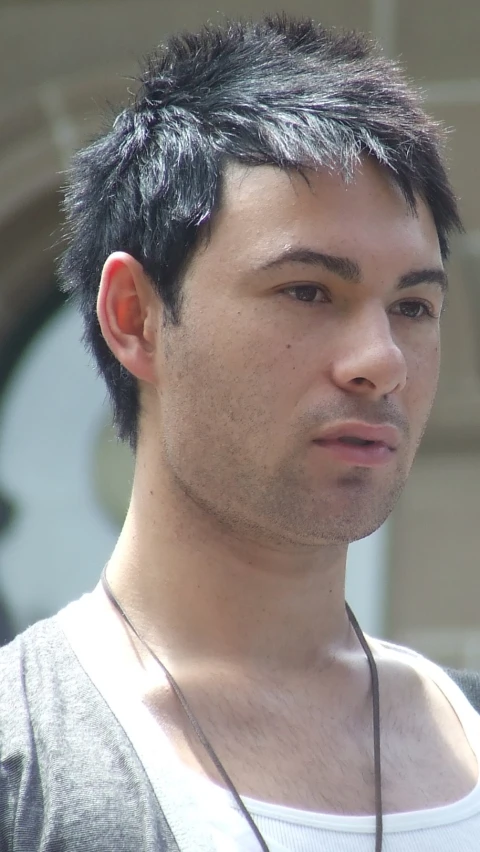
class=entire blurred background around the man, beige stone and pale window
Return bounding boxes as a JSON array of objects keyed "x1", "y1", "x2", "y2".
[{"x1": 0, "y1": 0, "x2": 480, "y2": 669}]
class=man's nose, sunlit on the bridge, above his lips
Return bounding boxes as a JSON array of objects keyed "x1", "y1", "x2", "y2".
[{"x1": 331, "y1": 306, "x2": 407, "y2": 399}]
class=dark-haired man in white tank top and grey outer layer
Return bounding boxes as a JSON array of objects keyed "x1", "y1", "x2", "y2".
[{"x1": 0, "y1": 17, "x2": 480, "y2": 852}]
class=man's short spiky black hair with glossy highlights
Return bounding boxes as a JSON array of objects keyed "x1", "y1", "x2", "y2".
[{"x1": 60, "y1": 15, "x2": 461, "y2": 447}]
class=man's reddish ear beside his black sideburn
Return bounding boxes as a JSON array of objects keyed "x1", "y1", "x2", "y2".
[{"x1": 97, "y1": 251, "x2": 161, "y2": 384}]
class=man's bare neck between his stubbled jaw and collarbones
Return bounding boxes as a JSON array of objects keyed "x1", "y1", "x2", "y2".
[{"x1": 107, "y1": 456, "x2": 358, "y2": 673}]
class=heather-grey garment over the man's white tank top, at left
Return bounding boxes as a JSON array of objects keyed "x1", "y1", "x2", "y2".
[{"x1": 0, "y1": 616, "x2": 172, "y2": 852}]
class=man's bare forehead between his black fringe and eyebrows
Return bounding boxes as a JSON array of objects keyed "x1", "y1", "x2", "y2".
[{"x1": 202, "y1": 160, "x2": 442, "y2": 266}]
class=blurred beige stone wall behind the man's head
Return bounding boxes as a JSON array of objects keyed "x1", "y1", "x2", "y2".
[{"x1": 0, "y1": 0, "x2": 480, "y2": 668}]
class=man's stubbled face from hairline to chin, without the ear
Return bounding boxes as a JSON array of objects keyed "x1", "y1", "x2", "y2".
[{"x1": 148, "y1": 161, "x2": 444, "y2": 545}]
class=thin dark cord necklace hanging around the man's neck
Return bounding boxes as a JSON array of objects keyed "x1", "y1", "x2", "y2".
[{"x1": 101, "y1": 566, "x2": 383, "y2": 852}]
